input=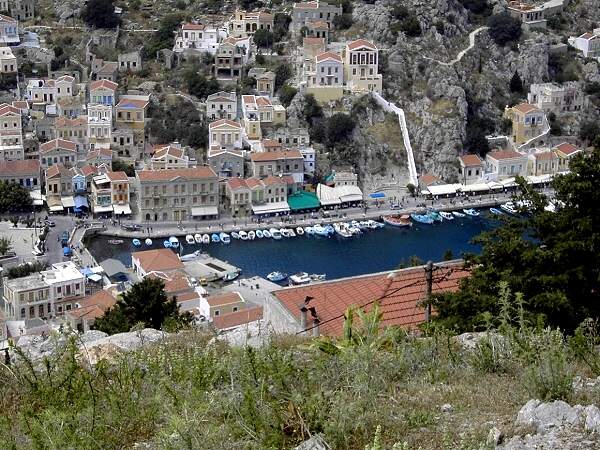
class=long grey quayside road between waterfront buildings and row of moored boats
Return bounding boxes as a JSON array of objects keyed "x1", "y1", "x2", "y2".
[{"x1": 74, "y1": 190, "x2": 551, "y2": 243}]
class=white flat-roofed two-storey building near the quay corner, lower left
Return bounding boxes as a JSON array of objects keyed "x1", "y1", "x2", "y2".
[{"x1": 3, "y1": 261, "x2": 86, "y2": 320}]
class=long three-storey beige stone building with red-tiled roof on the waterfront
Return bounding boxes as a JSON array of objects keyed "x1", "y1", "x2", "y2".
[{"x1": 136, "y1": 166, "x2": 219, "y2": 221}]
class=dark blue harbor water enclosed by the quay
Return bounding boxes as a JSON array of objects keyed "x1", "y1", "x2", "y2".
[{"x1": 87, "y1": 215, "x2": 497, "y2": 280}]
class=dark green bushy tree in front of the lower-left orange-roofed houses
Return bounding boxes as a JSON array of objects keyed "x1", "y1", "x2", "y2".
[{"x1": 94, "y1": 278, "x2": 190, "y2": 334}]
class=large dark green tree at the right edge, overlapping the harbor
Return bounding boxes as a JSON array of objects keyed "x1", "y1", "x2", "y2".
[{"x1": 433, "y1": 149, "x2": 600, "y2": 331}]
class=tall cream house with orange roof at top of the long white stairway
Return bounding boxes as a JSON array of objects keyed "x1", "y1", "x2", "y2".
[{"x1": 344, "y1": 39, "x2": 382, "y2": 92}]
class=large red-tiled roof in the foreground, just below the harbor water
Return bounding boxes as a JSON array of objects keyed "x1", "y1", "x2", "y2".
[{"x1": 273, "y1": 263, "x2": 469, "y2": 336}]
